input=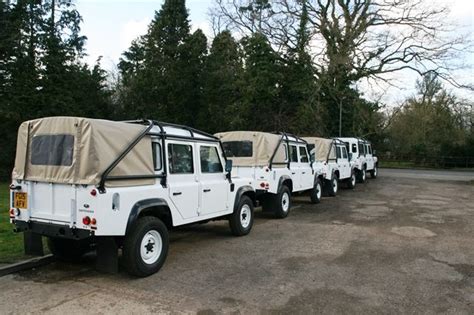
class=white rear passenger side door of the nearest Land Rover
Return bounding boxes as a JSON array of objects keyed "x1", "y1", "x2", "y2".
[{"x1": 166, "y1": 140, "x2": 199, "y2": 219}]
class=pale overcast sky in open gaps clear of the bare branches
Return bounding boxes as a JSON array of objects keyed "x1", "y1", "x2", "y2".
[{"x1": 74, "y1": 0, "x2": 474, "y2": 103}]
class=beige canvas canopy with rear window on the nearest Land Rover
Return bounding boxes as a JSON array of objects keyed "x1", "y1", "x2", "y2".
[{"x1": 12, "y1": 117, "x2": 154, "y2": 186}]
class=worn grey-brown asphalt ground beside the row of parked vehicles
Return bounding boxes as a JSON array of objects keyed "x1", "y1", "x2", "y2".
[{"x1": 0, "y1": 174, "x2": 474, "y2": 314}]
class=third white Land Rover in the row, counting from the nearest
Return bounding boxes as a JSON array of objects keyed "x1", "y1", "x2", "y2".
[{"x1": 303, "y1": 137, "x2": 356, "y2": 196}]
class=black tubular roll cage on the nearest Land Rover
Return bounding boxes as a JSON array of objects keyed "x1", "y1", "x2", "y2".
[{"x1": 97, "y1": 119, "x2": 230, "y2": 193}]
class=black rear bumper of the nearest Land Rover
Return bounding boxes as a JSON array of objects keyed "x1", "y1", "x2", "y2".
[{"x1": 13, "y1": 220, "x2": 94, "y2": 240}]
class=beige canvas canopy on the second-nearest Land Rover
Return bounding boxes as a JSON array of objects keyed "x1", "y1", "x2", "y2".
[{"x1": 215, "y1": 131, "x2": 287, "y2": 167}]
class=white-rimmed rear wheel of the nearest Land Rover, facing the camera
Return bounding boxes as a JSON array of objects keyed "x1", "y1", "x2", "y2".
[{"x1": 123, "y1": 217, "x2": 169, "y2": 277}]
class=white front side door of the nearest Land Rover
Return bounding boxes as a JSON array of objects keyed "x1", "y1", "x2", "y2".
[{"x1": 198, "y1": 144, "x2": 229, "y2": 215}]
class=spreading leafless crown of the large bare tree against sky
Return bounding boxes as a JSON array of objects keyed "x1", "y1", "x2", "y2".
[{"x1": 211, "y1": 0, "x2": 474, "y2": 89}]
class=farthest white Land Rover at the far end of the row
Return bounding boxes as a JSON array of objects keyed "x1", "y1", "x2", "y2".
[{"x1": 338, "y1": 138, "x2": 378, "y2": 183}]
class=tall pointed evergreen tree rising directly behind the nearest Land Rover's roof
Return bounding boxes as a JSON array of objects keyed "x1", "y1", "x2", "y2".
[{"x1": 120, "y1": 0, "x2": 206, "y2": 126}]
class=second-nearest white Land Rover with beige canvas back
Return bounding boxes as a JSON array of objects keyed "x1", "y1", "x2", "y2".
[{"x1": 216, "y1": 131, "x2": 322, "y2": 218}]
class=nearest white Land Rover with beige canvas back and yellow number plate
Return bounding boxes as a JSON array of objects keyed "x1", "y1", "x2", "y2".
[{"x1": 10, "y1": 117, "x2": 256, "y2": 276}]
